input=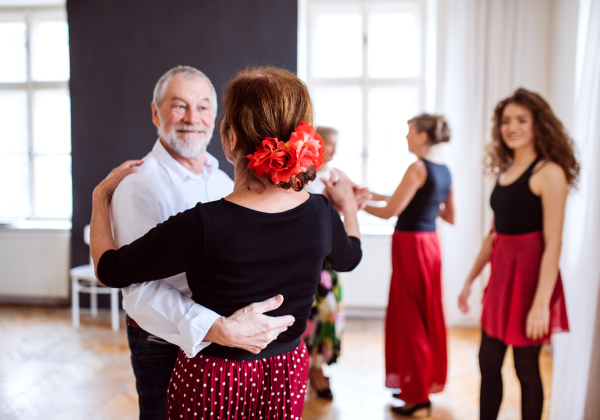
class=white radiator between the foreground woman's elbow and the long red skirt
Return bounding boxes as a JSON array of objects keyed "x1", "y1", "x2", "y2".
[{"x1": 342, "y1": 233, "x2": 392, "y2": 315}]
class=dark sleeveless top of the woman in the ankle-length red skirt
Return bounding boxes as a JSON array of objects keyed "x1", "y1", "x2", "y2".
[{"x1": 396, "y1": 159, "x2": 452, "y2": 232}]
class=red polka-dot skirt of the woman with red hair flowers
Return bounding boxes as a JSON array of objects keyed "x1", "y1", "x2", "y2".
[{"x1": 167, "y1": 341, "x2": 308, "y2": 420}]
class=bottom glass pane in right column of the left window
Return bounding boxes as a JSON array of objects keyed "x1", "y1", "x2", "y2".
[{"x1": 34, "y1": 156, "x2": 73, "y2": 219}]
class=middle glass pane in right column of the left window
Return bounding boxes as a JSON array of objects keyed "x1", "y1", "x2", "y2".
[{"x1": 33, "y1": 89, "x2": 71, "y2": 153}]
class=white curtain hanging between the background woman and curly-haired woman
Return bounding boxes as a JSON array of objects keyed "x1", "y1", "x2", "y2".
[{"x1": 436, "y1": 0, "x2": 552, "y2": 325}]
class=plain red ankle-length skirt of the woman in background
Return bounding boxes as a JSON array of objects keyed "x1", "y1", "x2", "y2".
[{"x1": 385, "y1": 231, "x2": 448, "y2": 403}]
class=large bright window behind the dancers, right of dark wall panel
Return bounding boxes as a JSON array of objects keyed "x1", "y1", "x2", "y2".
[{"x1": 299, "y1": 0, "x2": 425, "y2": 224}]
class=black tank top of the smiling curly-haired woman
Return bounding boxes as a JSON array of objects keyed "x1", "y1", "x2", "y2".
[{"x1": 490, "y1": 158, "x2": 543, "y2": 235}]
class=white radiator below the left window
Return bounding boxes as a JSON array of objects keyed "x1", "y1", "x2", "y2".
[{"x1": 0, "y1": 229, "x2": 71, "y2": 299}]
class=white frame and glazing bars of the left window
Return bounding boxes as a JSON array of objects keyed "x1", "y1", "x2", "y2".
[{"x1": 0, "y1": 6, "x2": 72, "y2": 221}]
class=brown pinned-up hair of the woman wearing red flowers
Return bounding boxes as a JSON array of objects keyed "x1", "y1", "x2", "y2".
[{"x1": 223, "y1": 67, "x2": 317, "y2": 191}]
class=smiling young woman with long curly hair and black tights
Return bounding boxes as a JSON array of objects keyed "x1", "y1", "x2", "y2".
[{"x1": 458, "y1": 89, "x2": 579, "y2": 420}]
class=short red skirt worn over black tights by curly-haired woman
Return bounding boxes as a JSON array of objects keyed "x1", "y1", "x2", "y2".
[{"x1": 481, "y1": 231, "x2": 569, "y2": 346}]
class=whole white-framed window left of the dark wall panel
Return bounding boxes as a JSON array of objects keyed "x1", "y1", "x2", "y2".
[{"x1": 0, "y1": 8, "x2": 73, "y2": 219}]
